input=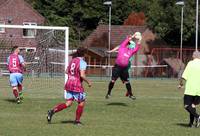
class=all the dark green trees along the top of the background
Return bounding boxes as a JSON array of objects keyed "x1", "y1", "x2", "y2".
[{"x1": 27, "y1": 0, "x2": 196, "y2": 46}]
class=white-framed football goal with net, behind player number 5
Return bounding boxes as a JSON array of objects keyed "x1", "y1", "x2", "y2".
[{"x1": 0, "y1": 25, "x2": 69, "y2": 95}]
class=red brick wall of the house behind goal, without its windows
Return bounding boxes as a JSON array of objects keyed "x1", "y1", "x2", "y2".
[{"x1": 0, "y1": 0, "x2": 45, "y2": 47}]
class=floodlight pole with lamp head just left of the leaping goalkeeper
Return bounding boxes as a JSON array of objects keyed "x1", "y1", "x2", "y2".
[{"x1": 103, "y1": 1, "x2": 112, "y2": 75}]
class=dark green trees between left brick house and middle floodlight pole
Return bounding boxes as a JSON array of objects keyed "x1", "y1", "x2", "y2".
[{"x1": 29, "y1": 0, "x2": 106, "y2": 46}]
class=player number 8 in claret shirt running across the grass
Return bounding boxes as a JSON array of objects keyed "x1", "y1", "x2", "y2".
[{"x1": 47, "y1": 47, "x2": 91, "y2": 125}]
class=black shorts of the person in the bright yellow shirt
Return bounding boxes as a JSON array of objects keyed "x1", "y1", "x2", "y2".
[{"x1": 183, "y1": 95, "x2": 200, "y2": 105}]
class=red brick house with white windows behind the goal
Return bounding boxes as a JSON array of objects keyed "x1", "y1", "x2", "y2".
[{"x1": 0, "y1": 0, "x2": 45, "y2": 49}]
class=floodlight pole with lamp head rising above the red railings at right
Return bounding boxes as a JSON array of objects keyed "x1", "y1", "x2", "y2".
[{"x1": 176, "y1": 1, "x2": 185, "y2": 61}]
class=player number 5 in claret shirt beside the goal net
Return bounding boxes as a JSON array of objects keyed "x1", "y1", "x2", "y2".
[{"x1": 7, "y1": 46, "x2": 25, "y2": 104}]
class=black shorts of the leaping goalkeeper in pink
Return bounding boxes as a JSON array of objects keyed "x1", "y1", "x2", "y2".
[{"x1": 112, "y1": 64, "x2": 129, "y2": 82}]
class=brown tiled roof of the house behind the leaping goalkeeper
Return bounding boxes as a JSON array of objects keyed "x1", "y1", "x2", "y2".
[{"x1": 83, "y1": 25, "x2": 166, "y2": 54}]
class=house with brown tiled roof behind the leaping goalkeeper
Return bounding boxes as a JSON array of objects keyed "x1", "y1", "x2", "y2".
[{"x1": 82, "y1": 25, "x2": 168, "y2": 75}]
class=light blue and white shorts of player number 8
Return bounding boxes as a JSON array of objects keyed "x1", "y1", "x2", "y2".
[{"x1": 64, "y1": 91, "x2": 86, "y2": 102}]
